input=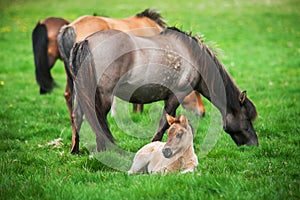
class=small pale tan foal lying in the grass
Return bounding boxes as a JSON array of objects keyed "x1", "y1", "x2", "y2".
[{"x1": 128, "y1": 114, "x2": 198, "y2": 174}]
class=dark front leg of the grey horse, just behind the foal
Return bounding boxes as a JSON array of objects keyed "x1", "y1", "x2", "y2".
[{"x1": 152, "y1": 95, "x2": 180, "y2": 142}]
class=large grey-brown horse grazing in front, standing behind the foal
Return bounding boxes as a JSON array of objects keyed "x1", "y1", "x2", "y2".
[{"x1": 70, "y1": 28, "x2": 258, "y2": 151}]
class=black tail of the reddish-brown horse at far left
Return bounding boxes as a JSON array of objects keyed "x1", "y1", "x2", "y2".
[{"x1": 32, "y1": 23, "x2": 55, "y2": 94}]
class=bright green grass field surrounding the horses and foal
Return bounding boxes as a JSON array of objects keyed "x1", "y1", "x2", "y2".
[{"x1": 0, "y1": 0, "x2": 300, "y2": 199}]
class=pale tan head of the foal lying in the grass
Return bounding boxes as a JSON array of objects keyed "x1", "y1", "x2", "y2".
[{"x1": 162, "y1": 114, "x2": 194, "y2": 158}]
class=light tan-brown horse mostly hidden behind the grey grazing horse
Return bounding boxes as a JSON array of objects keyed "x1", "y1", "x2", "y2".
[{"x1": 57, "y1": 9, "x2": 205, "y2": 153}]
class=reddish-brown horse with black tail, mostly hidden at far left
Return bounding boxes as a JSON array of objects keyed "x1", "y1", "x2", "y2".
[{"x1": 32, "y1": 17, "x2": 69, "y2": 94}]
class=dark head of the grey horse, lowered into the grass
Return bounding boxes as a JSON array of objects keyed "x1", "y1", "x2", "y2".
[{"x1": 223, "y1": 91, "x2": 258, "y2": 146}]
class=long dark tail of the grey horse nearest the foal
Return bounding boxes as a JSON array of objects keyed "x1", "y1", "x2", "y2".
[{"x1": 70, "y1": 40, "x2": 114, "y2": 151}]
